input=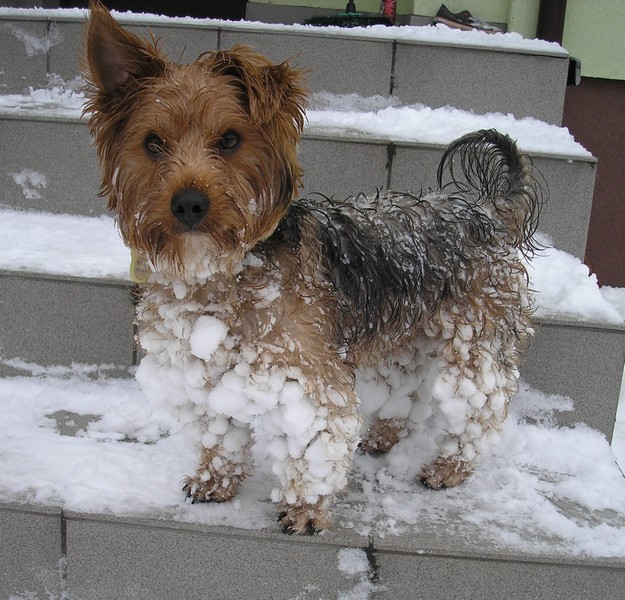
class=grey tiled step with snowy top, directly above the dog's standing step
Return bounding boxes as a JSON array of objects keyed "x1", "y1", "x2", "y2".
[{"x1": 0, "y1": 211, "x2": 625, "y2": 440}]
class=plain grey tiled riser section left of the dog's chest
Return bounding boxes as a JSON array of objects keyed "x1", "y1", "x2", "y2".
[{"x1": 0, "y1": 273, "x2": 135, "y2": 376}]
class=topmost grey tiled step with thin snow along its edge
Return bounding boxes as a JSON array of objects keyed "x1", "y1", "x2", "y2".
[{"x1": 0, "y1": 9, "x2": 568, "y2": 124}]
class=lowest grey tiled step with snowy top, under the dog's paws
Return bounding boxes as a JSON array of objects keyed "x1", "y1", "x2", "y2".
[{"x1": 0, "y1": 352, "x2": 625, "y2": 600}]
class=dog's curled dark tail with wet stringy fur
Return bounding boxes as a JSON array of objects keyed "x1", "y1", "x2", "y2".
[{"x1": 437, "y1": 129, "x2": 543, "y2": 255}]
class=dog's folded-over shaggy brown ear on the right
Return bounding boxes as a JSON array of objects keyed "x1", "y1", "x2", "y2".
[{"x1": 213, "y1": 46, "x2": 308, "y2": 132}]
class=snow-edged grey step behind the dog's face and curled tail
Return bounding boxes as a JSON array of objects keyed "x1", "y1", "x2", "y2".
[{"x1": 0, "y1": 103, "x2": 596, "y2": 257}]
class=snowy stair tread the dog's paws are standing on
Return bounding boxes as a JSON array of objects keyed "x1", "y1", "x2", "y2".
[{"x1": 0, "y1": 369, "x2": 625, "y2": 560}]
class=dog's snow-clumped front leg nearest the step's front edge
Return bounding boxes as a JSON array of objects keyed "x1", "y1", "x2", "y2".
[{"x1": 268, "y1": 382, "x2": 360, "y2": 534}]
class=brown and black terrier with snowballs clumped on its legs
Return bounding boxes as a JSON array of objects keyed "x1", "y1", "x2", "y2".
[{"x1": 83, "y1": 2, "x2": 541, "y2": 534}]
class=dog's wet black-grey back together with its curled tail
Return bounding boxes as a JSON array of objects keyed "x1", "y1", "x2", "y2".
[{"x1": 272, "y1": 130, "x2": 541, "y2": 346}]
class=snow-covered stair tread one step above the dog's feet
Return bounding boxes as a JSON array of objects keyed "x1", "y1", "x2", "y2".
[{"x1": 0, "y1": 199, "x2": 625, "y2": 326}]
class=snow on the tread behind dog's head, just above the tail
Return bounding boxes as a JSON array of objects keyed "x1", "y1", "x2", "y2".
[{"x1": 0, "y1": 86, "x2": 592, "y2": 158}]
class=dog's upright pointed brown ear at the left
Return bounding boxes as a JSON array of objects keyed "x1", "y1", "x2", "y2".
[{"x1": 83, "y1": 0, "x2": 165, "y2": 98}]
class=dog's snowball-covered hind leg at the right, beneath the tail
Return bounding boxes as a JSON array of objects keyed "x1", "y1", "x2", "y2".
[{"x1": 421, "y1": 302, "x2": 520, "y2": 489}]
